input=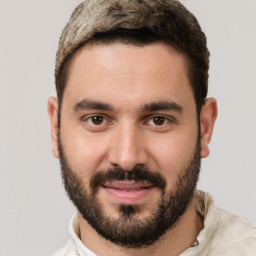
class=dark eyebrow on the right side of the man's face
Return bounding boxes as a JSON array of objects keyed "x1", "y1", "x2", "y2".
[{"x1": 141, "y1": 101, "x2": 183, "y2": 113}]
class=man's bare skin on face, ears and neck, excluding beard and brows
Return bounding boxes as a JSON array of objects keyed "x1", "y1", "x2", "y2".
[{"x1": 48, "y1": 43, "x2": 217, "y2": 256}]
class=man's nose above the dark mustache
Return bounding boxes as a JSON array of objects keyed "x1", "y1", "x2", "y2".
[{"x1": 109, "y1": 124, "x2": 148, "y2": 171}]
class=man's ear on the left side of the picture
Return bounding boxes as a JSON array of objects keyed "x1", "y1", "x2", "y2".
[{"x1": 47, "y1": 96, "x2": 59, "y2": 158}]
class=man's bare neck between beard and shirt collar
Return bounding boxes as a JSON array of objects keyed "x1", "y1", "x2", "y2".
[{"x1": 78, "y1": 199, "x2": 203, "y2": 256}]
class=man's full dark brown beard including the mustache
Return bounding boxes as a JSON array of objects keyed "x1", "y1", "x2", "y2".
[{"x1": 59, "y1": 136, "x2": 201, "y2": 248}]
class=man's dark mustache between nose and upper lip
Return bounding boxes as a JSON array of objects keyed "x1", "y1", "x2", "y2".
[{"x1": 90, "y1": 166, "x2": 166, "y2": 191}]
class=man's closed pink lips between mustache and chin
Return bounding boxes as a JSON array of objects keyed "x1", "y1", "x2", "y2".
[{"x1": 103, "y1": 181, "x2": 154, "y2": 204}]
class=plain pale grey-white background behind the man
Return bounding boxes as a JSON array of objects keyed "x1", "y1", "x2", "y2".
[{"x1": 0, "y1": 0, "x2": 256, "y2": 256}]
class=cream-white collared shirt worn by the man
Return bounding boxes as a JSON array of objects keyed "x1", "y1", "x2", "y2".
[{"x1": 52, "y1": 191, "x2": 256, "y2": 256}]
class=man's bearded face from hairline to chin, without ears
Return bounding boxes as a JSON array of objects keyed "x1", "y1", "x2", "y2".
[{"x1": 52, "y1": 43, "x2": 204, "y2": 247}]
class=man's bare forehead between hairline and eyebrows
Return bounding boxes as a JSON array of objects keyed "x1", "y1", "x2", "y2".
[{"x1": 63, "y1": 43, "x2": 193, "y2": 111}]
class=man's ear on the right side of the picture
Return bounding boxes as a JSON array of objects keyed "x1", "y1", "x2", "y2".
[{"x1": 200, "y1": 98, "x2": 218, "y2": 158}]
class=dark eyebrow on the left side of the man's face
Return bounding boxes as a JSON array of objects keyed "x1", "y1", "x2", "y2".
[{"x1": 74, "y1": 99, "x2": 114, "y2": 112}]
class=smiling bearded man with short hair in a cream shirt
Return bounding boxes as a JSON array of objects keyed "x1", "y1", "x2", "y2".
[{"x1": 48, "y1": 0, "x2": 256, "y2": 256}]
